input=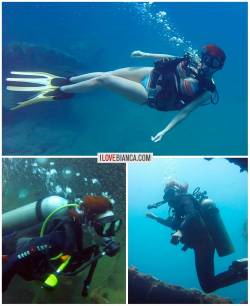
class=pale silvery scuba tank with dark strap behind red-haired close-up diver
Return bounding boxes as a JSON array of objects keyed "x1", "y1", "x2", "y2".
[{"x1": 2, "y1": 195, "x2": 68, "y2": 235}]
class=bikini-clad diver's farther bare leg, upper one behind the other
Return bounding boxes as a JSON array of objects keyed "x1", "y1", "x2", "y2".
[{"x1": 70, "y1": 67, "x2": 153, "y2": 83}]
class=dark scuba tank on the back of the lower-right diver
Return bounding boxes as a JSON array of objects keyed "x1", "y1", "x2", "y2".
[{"x1": 193, "y1": 187, "x2": 234, "y2": 257}]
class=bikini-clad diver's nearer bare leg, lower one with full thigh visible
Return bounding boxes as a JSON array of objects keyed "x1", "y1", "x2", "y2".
[{"x1": 60, "y1": 74, "x2": 148, "y2": 104}]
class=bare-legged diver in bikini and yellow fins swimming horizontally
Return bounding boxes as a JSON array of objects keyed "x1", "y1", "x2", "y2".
[{"x1": 7, "y1": 44, "x2": 226, "y2": 142}]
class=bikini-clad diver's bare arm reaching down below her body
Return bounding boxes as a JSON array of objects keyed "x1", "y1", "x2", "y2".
[{"x1": 151, "y1": 91, "x2": 211, "y2": 142}]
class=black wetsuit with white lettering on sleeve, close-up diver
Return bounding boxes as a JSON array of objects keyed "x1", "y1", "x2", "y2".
[{"x1": 3, "y1": 218, "x2": 89, "y2": 291}]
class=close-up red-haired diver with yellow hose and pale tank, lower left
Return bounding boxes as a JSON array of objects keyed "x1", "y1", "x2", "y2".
[{"x1": 2, "y1": 196, "x2": 121, "y2": 296}]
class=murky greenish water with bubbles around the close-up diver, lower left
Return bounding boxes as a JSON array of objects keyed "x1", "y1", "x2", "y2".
[{"x1": 3, "y1": 158, "x2": 126, "y2": 304}]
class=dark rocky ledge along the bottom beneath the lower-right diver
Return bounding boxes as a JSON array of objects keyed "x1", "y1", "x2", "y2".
[{"x1": 128, "y1": 268, "x2": 233, "y2": 304}]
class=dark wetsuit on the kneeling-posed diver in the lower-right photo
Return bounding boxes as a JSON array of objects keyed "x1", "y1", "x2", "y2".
[{"x1": 157, "y1": 194, "x2": 245, "y2": 293}]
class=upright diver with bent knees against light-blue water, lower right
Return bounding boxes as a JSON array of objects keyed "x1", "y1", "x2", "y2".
[{"x1": 146, "y1": 181, "x2": 248, "y2": 293}]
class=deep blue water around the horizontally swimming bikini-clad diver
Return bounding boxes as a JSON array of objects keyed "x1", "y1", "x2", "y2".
[{"x1": 3, "y1": 2, "x2": 247, "y2": 155}]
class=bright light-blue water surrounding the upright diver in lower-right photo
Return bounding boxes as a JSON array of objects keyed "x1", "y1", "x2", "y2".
[{"x1": 128, "y1": 158, "x2": 248, "y2": 303}]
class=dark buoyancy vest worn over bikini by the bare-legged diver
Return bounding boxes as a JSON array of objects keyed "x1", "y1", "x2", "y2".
[{"x1": 148, "y1": 55, "x2": 216, "y2": 111}]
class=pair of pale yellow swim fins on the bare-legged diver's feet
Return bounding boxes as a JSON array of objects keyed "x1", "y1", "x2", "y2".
[{"x1": 6, "y1": 71, "x2": 73, "y2": 110}]
